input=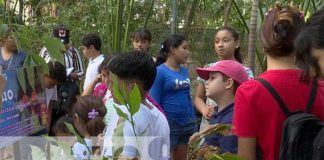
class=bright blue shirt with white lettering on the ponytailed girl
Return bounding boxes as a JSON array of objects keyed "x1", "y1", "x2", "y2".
[{"x1": 150, "y1": 64, "x2": 195, "y2": 125}]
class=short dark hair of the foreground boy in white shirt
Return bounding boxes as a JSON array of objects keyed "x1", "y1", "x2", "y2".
[{"x1": 108, "y1": 50, "x2": 156, "y2": 91}]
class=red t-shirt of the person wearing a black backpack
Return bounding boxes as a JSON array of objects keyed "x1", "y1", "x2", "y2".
[{"x1": 233, "y1": 69, "x2": 324, "y2": 160}]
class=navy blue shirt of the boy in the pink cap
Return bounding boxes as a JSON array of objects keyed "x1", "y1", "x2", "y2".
[{"x1": 205, "y1": 103, "x2": 238, "y2": 154}]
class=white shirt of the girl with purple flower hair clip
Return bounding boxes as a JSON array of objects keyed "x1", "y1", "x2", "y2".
[{"x1": 72, "y1": 138, "x2": 92, "y2": 160}]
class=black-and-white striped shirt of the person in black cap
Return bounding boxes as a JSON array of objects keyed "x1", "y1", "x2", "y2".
[{"x1": 39, "y1": 47, "x2": 84, "y2": 80}]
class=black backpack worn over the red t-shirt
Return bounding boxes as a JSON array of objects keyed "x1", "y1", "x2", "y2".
[{"x1": 256, "y1": 78, "x2": 324, "y2": 160}]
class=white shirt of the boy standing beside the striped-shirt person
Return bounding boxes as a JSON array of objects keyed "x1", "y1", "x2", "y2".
[{"x1": 83, "y1": 54, "x2": 105, "y2": 90}]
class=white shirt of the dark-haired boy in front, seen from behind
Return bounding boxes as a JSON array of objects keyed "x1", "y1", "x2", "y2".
[{"x1": 103, "y1": 101, "x2": 170, "y2": 159}]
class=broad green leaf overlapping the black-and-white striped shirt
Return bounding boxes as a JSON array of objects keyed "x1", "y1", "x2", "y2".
[{"x1": 43, "y1": 36, "x2": 65, "y2": 64}]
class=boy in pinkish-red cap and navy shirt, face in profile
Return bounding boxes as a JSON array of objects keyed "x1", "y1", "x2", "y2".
[{"x1": 197, "y1": 60, "x2": 248, "y2": 154}]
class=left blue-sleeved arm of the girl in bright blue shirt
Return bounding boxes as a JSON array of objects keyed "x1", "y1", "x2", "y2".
[{"x1": 150, "y1": 69, "x2": 163, "y2": 105}]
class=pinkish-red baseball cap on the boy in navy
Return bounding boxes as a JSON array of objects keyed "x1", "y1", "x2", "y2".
[{"x1": 197, "y1": 60, "x2": 249, "y2": 84}]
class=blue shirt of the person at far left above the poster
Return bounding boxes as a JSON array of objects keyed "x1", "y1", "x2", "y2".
[{"x1": 0, "y1": 49, "x2": 27, "y2": 70}]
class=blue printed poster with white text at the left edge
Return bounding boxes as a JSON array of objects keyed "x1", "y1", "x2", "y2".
[{"x1": 0, "y1": 67, "x2": 48, "y2": 148}]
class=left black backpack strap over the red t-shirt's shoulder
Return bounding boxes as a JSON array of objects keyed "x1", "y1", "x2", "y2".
[{"x1": 255, "y1": 78, "x2": 290, "y2": 117}]
